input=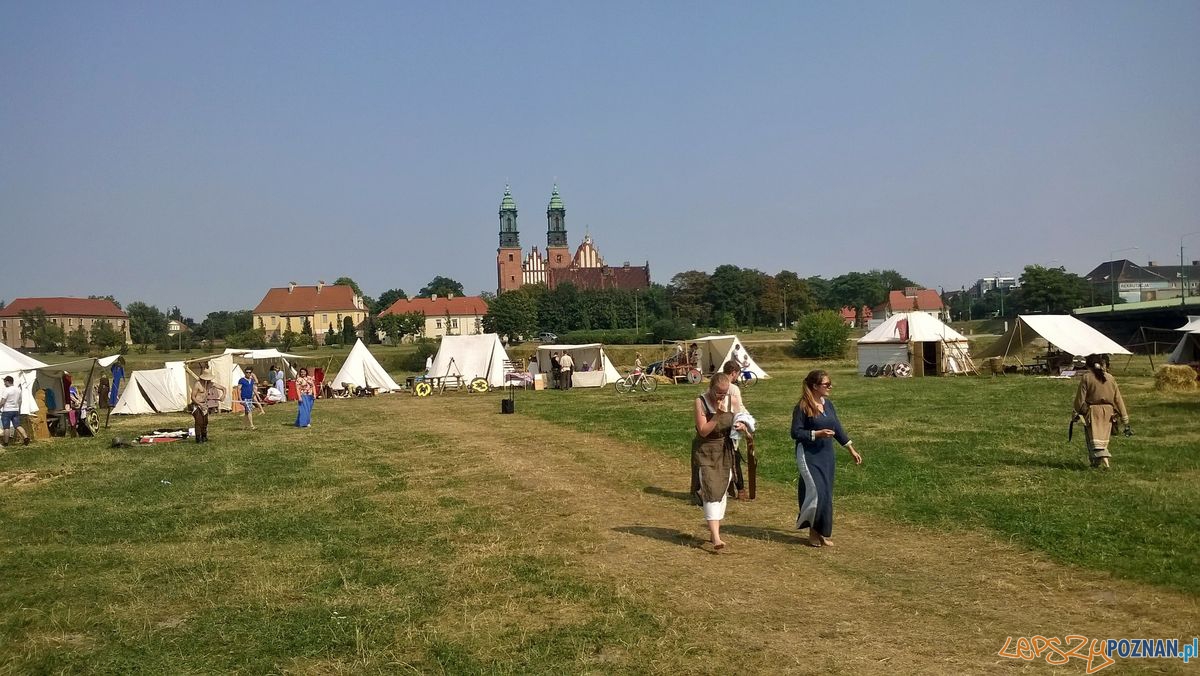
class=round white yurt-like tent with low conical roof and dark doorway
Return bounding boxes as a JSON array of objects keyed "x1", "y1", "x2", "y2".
[{"x1": 858, "y1": 312, "x2": 970, "y2": 376}]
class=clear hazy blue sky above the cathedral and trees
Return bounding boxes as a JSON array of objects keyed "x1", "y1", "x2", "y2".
[{"x1": 0, "y1": 0, "x2": 1200, "y2": 318}]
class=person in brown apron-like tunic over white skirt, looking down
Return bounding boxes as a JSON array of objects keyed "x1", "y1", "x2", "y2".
[{"x1": 691, "y1": 373, "x2": 740, "y2": 551}]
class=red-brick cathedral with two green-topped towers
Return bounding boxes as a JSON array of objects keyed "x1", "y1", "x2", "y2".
[{"x1": 496, "y1": 185, "x2": 650, "y2": 293}]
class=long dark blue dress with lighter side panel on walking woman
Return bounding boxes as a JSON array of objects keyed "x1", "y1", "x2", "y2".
[{"x1": 792, "y1": 399, "x2": 850, "y2": 538}]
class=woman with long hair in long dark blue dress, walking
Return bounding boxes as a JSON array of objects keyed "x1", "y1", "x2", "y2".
[{"x1": 792, "y1": 370, "x2": 863, "y2": 546}]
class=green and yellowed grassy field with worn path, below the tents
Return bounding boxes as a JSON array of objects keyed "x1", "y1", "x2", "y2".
[{"x1": 0, "y1": 351, "x2": 1200, "y2": 674}]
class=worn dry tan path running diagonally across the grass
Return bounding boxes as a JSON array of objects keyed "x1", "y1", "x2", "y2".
[{"x1": 405, "y1": 397, "x2": 1200, "y2": 674}]
